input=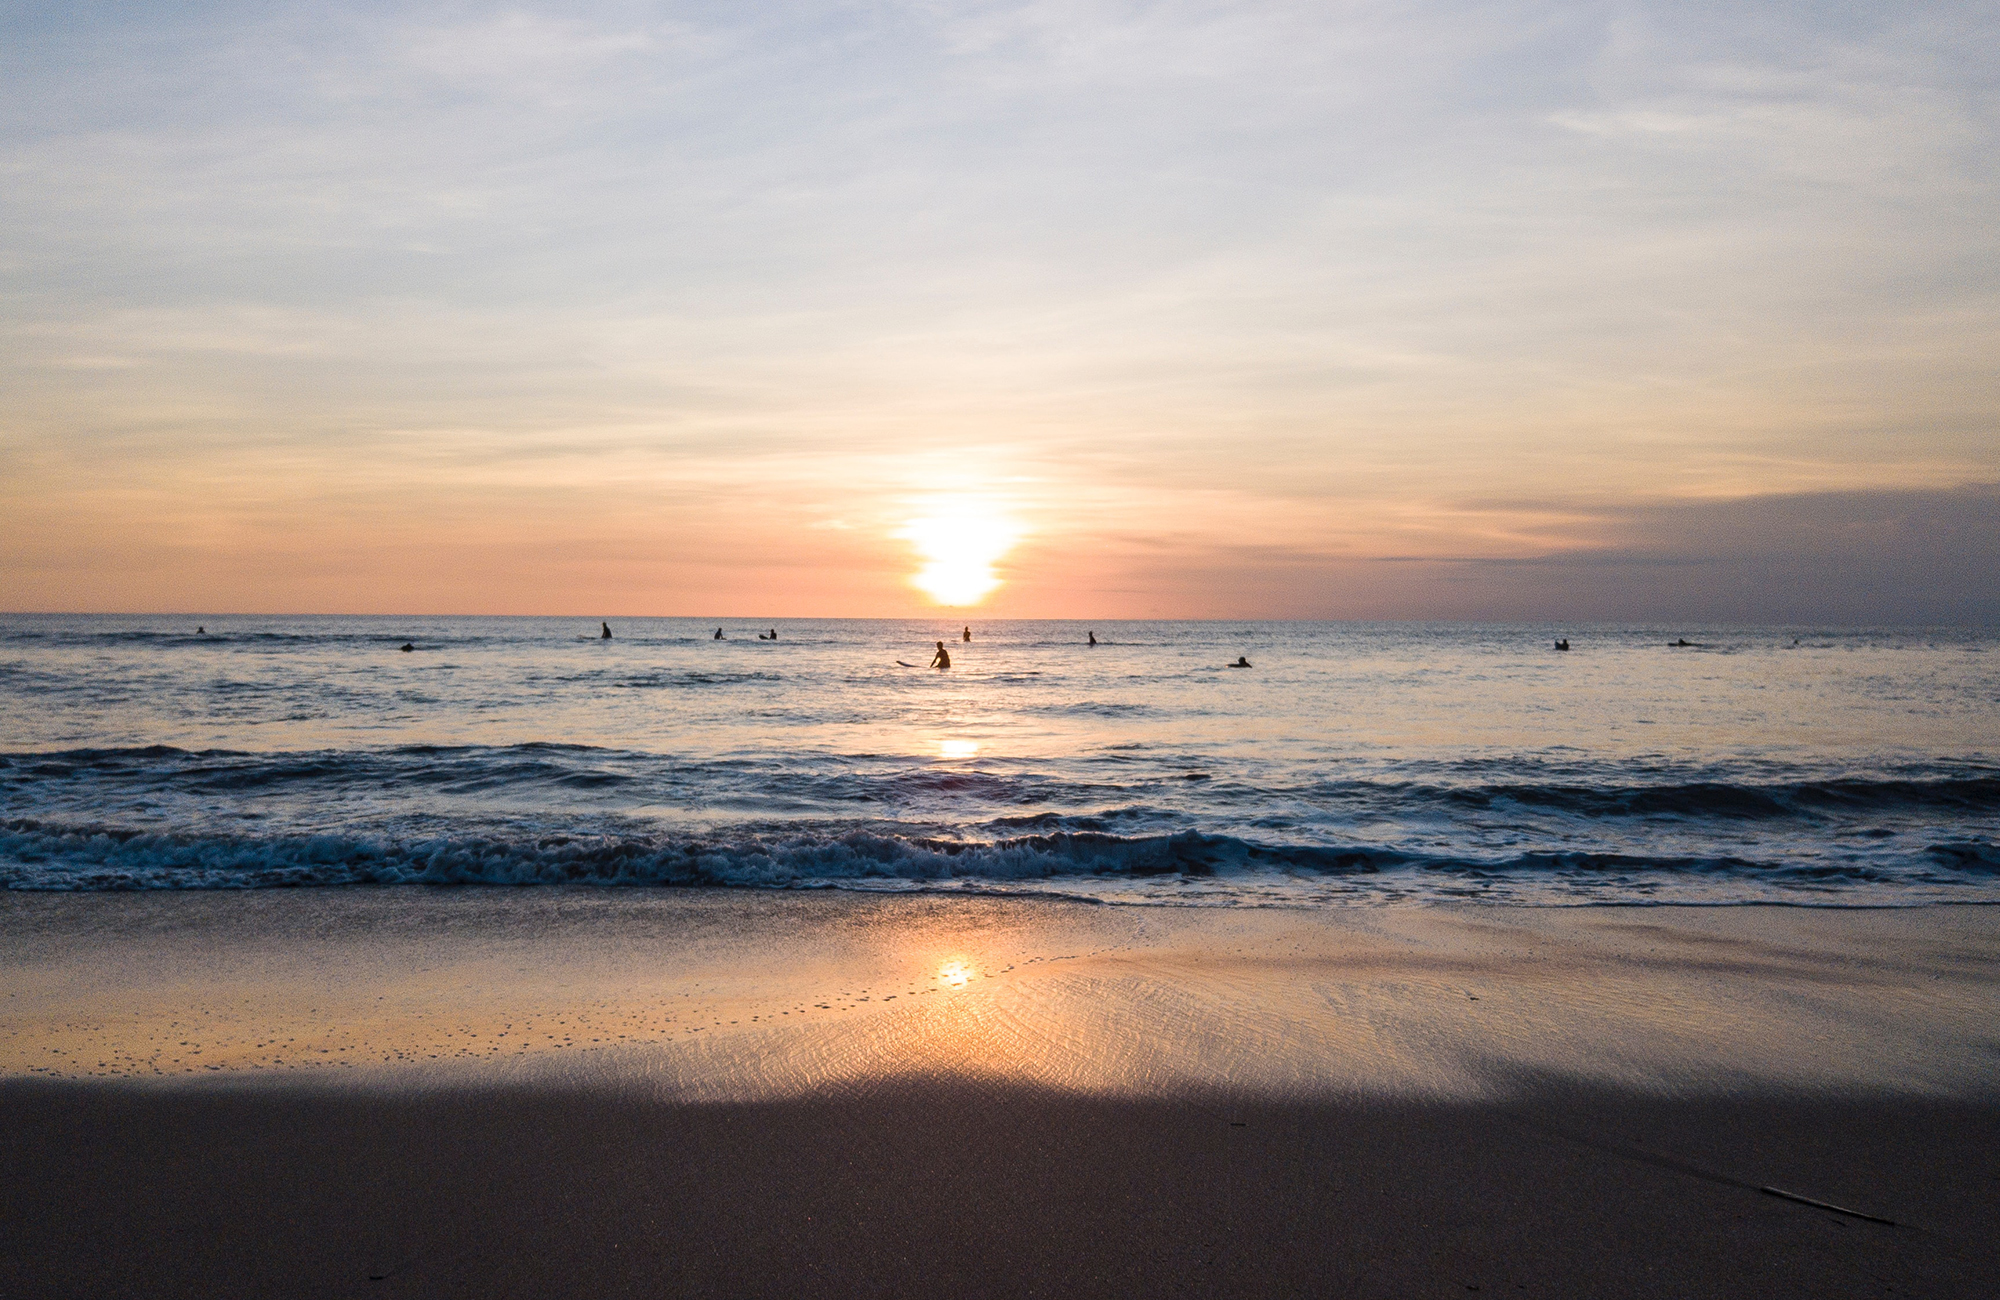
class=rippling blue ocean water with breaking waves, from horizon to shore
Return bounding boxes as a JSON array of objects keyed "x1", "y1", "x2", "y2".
[{"x1": 0, "y1": 616, "x2": 2000, "y2": 906}]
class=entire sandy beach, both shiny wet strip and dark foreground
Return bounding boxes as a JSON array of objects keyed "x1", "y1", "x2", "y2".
[{"x1": 0, "y1": 890, "x2": 2000, "y2": 1296}]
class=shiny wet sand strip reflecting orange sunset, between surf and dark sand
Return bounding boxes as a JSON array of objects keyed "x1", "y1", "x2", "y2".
[{"x1": 0, "y1": 890, "x2": 2000, "y2": 1098}]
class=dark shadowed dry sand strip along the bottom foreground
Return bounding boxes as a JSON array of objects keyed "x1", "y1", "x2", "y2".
[{"x1": 0, "y1": 1080, "x2": 2000, "y2": 1298}]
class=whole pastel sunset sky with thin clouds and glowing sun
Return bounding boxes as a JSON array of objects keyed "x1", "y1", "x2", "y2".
[{"x1": 0, "y1": 0, "x2": 2000, "y2": 624}]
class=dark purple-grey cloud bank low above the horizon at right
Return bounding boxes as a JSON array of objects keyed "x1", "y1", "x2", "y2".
[{"x1": 1100, "y1": 484, "x2": 2000, "y2": 626}]
